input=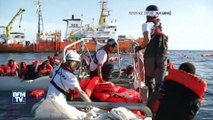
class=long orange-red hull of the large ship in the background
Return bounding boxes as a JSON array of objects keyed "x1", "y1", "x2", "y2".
[{"x1": 0, "y1": 39, "x2": 142, "y2": 53}]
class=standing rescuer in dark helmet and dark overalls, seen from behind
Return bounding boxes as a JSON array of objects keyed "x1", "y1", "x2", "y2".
[{"x1": 135, "y1": 5, "x2": 168, "y2": 107}]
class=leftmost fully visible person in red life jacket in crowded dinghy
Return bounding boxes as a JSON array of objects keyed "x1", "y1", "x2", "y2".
[{"x1": 3, "y1": 59, "x2": 19, "y2": 76}]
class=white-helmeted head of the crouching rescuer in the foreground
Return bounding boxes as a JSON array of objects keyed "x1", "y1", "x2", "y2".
[{"x1": 66, "y1": 51, "x2": 81, "y2": 71}]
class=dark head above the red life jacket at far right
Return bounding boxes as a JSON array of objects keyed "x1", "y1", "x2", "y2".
[{"x1": 178, "y1": 62, "x2": 196, "y2": 74}]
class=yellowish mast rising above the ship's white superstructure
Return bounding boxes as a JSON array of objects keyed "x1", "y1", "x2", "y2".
[{"x1": 99, "y1": 0, "x2": 109, "y2": 26}]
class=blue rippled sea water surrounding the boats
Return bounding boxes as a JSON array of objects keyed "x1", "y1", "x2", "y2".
[{"x1": 0, "y1": 50, "x2": 213, "y2": 120}]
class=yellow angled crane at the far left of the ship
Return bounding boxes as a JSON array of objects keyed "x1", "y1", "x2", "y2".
[{"x1": 1, "y1": 8, "x2": 25, "y2": 40}]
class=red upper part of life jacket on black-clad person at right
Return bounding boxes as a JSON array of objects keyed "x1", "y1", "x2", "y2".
[{"x1": 166, "y1": 69, "x2": 207, "y2": 101}]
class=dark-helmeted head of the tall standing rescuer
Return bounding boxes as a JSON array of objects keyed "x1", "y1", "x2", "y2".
[{"x1": 146, "y1": 5, "x2": 159, "y2": 22}]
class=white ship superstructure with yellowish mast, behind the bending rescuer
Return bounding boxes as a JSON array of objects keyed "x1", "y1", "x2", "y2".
[{"x1": 63, "y1": 0, "x2": 117, "y2": 42}]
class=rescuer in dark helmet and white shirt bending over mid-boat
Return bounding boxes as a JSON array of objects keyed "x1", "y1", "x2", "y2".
[{"x1": 89, "y1": 39, "x2": 118, "y2": 81}]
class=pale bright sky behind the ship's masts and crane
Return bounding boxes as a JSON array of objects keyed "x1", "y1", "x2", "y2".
[{"x1": 0, "y1": 0, "x2": 213, "y2": 50}]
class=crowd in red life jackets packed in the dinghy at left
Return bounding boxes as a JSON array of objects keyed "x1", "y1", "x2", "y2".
[{"x1": 0, "y1": 53, "x2": 61, "y2": 80}]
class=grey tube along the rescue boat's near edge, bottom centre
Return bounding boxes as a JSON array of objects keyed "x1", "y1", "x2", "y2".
[{"x1": 68, "y1": 101, "x2": 152, "y2": 117}]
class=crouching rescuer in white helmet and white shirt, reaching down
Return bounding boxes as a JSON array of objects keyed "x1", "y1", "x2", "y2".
[{"x1": 34, "y1": 51, "x2": 92, "y2": 120}]
